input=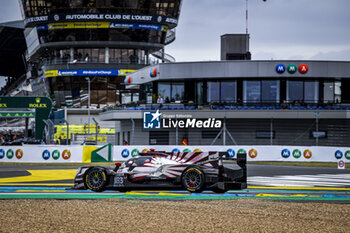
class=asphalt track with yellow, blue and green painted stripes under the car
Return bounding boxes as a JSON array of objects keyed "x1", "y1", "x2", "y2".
[{"x1": 0, "y1": 164, "x2": 350, "y2": 204}]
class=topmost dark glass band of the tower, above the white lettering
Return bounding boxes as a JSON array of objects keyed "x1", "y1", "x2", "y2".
[{"x1": 22, "y1": 0, "x2": 181, "y2": 18}]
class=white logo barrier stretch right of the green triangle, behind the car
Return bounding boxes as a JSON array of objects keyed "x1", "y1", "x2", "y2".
[{"x1": 113, "y1": 146, "x2": 350, "y2": 162}]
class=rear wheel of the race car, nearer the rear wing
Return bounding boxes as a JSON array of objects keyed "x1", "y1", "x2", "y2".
[{"x1": 181, "y1": 167, "x2": 205, "y2": 193}]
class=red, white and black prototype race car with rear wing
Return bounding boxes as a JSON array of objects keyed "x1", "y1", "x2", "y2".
[{"x1": 73, "y1": 151, "x2": 247, "y2": 193}]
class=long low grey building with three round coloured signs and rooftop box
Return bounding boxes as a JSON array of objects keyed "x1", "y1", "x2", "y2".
[{"x1": 101, "y1": 34, "x2": 350, "y2": 146}]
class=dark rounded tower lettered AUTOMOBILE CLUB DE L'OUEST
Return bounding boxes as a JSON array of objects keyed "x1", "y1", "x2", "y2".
[{"x1": 22, "y1": 0, "x2": 181, "y2": 108}]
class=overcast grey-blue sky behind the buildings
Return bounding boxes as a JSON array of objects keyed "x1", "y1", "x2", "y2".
[{"x1": 0, "y1": 0, "x2": 350, "y2": 61}]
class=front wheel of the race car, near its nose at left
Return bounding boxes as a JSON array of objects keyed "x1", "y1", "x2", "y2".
[{"x1": 84, "y1": 168, "x2": 107, "y2": 192}]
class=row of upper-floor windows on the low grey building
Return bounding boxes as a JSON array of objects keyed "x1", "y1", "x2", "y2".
[{"x1": 148, "y1": 79, "x2": 342, "y2": 106}]
